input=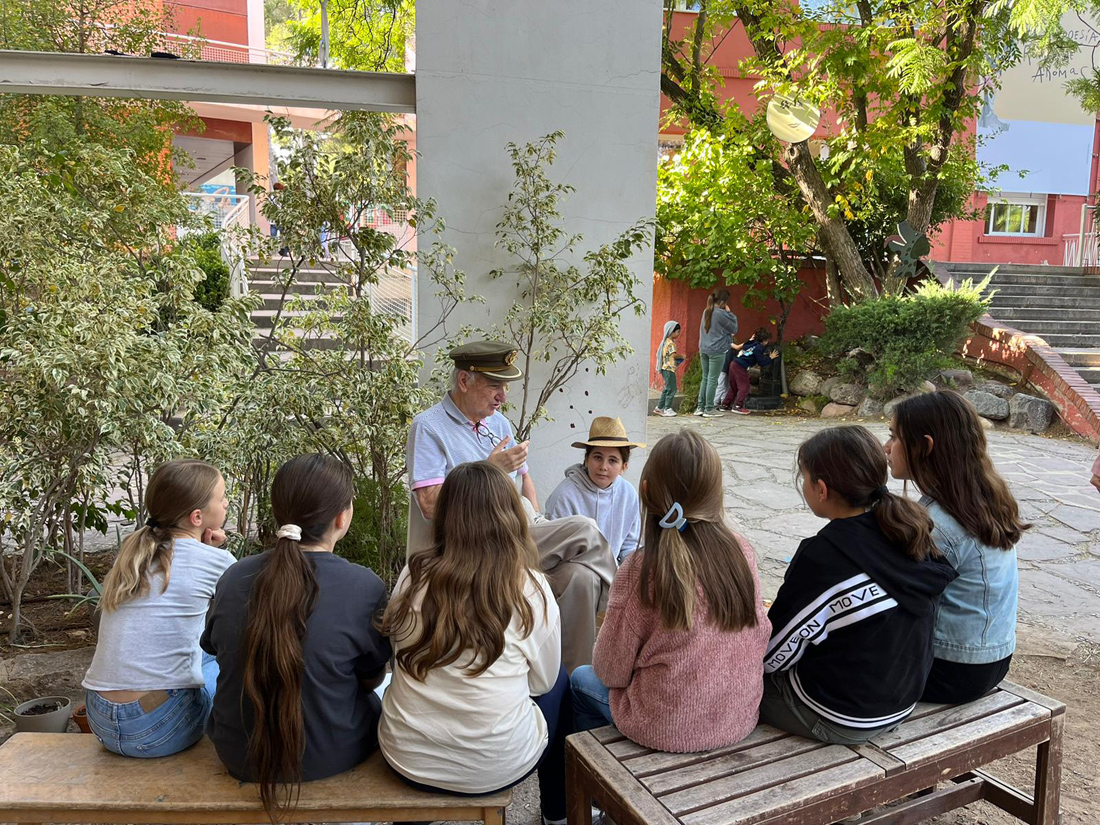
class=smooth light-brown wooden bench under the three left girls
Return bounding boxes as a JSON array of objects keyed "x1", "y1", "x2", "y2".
[{"x1": 0, "y1": 734, "x2": 512, "y2": 825}]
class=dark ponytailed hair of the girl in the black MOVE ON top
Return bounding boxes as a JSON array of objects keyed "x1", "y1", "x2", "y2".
[{"x1": 799, "y1": 425, "x2": 941, "y2": 561}]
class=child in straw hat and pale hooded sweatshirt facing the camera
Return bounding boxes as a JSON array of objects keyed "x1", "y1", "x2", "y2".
[{"x1": 546, "y1": 416, "x2": 646, "y2": 564}]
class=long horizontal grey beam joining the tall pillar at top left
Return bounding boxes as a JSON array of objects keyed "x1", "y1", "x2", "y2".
[{"x1": 0, "y1": 50, "x2": 416, "y2": 113}]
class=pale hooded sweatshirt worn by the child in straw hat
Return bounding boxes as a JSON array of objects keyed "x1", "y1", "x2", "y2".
[{"x1": 543, "y1": 464, "x2": 641, "y2": 563}]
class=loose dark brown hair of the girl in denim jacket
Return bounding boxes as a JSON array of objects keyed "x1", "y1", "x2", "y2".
[{"x1": 893, "y1": 391, "x2": 1031, "y2": 550}]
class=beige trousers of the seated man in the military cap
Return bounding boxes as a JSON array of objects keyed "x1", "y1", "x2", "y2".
[{"x1": 408, "y1": 495, "x2": 618, "y2": 673}]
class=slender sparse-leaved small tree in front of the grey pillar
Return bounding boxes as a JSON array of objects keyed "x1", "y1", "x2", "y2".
[{"x1": 490, "y1": 132, "x2": 653, "y2": 441}]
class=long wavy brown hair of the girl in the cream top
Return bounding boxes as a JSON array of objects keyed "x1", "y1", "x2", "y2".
[{"x1": 382, "y1": 461, "x2": 547, "y2": 682}]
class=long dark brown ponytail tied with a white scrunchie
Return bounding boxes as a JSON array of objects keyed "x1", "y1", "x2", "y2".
[{"x1": 241, "y1": 454, "x2": 355, "y2": 822}]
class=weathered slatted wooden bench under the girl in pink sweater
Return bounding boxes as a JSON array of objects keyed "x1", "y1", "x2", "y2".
[{"x1": 565, "y1": 682, "x2": 1066, "y2": 825}]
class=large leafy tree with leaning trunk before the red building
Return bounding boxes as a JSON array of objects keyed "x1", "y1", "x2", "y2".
[{"x1": 661, "y1": 0, "x2": 1054, "y2": 297}]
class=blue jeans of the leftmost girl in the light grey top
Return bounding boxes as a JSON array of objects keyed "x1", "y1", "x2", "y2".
[{"x1": 85, "y1": 653, "x2": 218, "y2": 759}]
